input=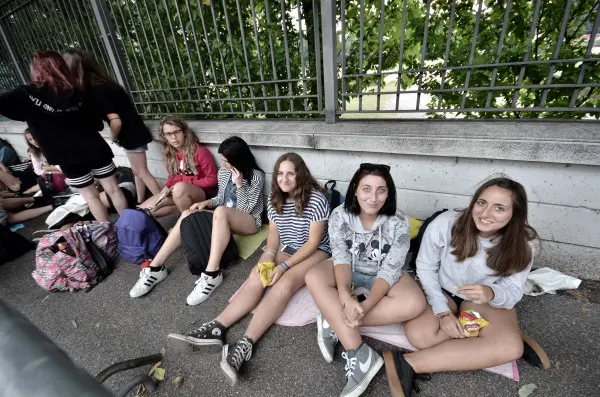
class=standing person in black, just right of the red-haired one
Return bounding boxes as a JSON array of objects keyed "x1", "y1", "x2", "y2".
[{"x1": 63, "y1": 49, "x2": 160, "y2": 204}]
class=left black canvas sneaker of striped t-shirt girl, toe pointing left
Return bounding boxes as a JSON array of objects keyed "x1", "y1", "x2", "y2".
[{"x1": 167, "y1": 320, "x2": 227, "y2": 353}]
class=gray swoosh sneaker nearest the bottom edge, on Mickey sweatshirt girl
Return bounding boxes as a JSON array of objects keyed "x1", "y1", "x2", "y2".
[{"x1": 340, "y1": 343, "x2": 383, "y2": 397}]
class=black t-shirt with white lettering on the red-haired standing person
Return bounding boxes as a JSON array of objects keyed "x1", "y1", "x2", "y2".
[{"x1": 0, "y1": 85, "x2": 114, "y2": 166}]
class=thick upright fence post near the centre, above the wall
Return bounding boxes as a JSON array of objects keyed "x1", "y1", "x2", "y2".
[{"x1": 321, "y1": 0, "x2": 338, "y2": 124}]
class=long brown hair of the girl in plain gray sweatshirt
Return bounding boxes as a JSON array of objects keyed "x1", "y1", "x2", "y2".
[{"x1": 450, "y1": 178, "x2": 538, "y2": 277}]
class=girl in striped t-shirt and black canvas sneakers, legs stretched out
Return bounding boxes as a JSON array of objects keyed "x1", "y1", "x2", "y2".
[{"x1": 169, "y1": 153, "x2": 330, "y2": 384}]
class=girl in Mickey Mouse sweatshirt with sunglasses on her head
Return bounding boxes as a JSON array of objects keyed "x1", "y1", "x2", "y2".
[{"x1": 306, "y1": 164, "x2": 426, "y2": 397}]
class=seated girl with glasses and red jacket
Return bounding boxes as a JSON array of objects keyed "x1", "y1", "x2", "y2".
[{"x1": 140, "y1": 116, "x2": 217, "y2": 217}]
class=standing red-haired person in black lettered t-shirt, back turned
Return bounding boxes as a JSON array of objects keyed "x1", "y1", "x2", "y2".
[{"x1": 0, "y1": 51, "x2": 127, "y2": 221}]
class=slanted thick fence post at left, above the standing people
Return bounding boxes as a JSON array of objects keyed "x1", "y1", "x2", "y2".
[{"x1": 90, "y1": 0, "x2": 133, "y2": 92}]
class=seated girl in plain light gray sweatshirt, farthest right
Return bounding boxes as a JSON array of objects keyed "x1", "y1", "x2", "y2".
[{"x1": 384, "y1": 178, "x2": 541, "y2": 396}]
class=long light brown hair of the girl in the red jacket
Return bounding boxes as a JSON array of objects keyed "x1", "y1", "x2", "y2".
[{"x1": 158, "y1": 116, "x2": 200, "y2": 175}]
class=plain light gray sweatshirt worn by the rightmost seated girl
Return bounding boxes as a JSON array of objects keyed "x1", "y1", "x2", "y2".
[{"x1": 417, "y1": 211, "x2": 535, "y2": 314}]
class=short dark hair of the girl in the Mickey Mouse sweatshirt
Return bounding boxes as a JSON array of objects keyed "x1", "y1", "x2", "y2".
[{"x1": 344, "y1": 164, "x2": 396, "y2": 216}]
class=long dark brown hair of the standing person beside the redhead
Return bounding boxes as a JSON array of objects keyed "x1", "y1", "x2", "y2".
[{"x1": 62, "y1": 48, "x2": 121, "y2": 91}]
